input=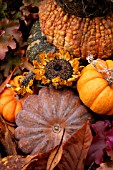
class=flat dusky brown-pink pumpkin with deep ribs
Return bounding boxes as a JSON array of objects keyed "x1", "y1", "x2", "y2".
[{"x1": 15, "y1": 86, "x2": 90, "y2": 154}]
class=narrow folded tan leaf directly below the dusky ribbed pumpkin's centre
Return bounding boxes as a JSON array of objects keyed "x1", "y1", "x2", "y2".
[{"x1": 46, "y1": 145, "x2": 63, "y2": 170}]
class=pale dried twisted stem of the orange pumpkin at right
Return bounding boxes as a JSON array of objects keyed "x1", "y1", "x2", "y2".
[{"x1": 87, "y1": 55, "x2": 113, "y2": 85}]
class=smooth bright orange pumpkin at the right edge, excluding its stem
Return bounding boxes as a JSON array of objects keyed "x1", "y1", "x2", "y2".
[{"x1": 77, "y1": 60, "x2": 113, "y2": 115}]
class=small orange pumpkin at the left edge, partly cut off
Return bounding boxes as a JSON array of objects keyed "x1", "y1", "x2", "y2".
[{"x1": 0, "y1": 89, "x2": 25, "y2": 122}]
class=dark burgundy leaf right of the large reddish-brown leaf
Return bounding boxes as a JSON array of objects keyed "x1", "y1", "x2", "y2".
[{"x1": 86, "y1": 121, "x2": 110, "y2": 166}]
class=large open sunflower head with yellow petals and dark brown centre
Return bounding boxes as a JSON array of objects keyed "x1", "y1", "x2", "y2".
[{"x1": 32, "y1": 50, "x2": 82, "y2": 87}]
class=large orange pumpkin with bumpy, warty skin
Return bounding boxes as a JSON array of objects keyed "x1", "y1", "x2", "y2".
[{"x1": 39, "y1": 0, "x2": 113, "y2": 59}]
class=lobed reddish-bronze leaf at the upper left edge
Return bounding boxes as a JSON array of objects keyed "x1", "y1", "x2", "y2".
[{"x1": 0, "y1": 18, "x2": 22, "y2": 60}]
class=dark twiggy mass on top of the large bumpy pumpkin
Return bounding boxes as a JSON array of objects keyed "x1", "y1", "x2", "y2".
[{"x1": 55, "y1": 0, "x2": 113, "y2": 18}]
